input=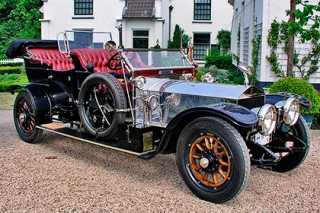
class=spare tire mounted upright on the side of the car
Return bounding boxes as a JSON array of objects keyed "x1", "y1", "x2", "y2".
[{"x1": 79, "y1": 72, "x2": 127, "y2": 138}]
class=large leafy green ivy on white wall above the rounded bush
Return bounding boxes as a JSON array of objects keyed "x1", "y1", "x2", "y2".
[{"x1": 266, "y1": 0, "x2": 320, "y2": 80}]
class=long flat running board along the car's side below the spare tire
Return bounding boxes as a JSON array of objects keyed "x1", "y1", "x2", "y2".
[{"x1": 37, "y1": 123, "x2": 155, "y2": 156}]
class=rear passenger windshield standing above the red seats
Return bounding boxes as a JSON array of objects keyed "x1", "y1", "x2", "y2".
[{"x1": 58, "y1": 31, "x2": 112, "y2": 52}]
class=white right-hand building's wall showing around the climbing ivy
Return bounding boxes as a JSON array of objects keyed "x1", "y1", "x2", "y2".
[{"x1": 228, "y1": 0, "x2": 320, "y2": 87}]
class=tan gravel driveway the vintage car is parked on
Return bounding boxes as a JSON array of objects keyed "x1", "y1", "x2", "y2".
[{"x1": 0, "y1": 110, "x2": 320, "y2": 212}]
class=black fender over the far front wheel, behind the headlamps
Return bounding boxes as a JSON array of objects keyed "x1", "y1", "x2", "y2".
[{"x1": 266, "y1": 92, "x2": 312, "y2": 109}]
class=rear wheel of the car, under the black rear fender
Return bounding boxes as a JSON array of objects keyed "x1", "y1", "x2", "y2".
[{"x1": 13, "y1": 92, "x2": 42, "y2": 143}]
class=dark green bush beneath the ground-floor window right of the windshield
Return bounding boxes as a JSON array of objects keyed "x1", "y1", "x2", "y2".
[{"x1": 205, "y1": 48, "x2": 232, "y2": 71}]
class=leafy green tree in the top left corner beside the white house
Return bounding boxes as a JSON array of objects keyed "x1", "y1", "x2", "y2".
[{"x1": 0, "y1": 0, "x2": 42, "y2": 59}]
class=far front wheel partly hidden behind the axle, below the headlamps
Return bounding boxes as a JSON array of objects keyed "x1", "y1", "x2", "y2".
[{"x1": 268, "y1": 116, "x2": 310, "y2": 172}]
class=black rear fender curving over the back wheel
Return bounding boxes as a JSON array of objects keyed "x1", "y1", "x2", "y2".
[{"x1": 8, "y1": 84, "x2": 52, "y2": 125}]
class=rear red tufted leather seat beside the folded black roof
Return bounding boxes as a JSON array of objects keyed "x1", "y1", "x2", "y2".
[{"x1": 28, "y1": 49, "x2": 74, "y2": 71}]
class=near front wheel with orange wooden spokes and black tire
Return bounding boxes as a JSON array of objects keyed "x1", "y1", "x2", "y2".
[{"x1": 176, "y1": 117, "x2": 250, "y2": 203}]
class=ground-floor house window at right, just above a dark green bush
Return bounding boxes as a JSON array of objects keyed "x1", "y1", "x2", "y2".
[{"x1": 193, "y1": 33, "x2": 210, "y2": 60}]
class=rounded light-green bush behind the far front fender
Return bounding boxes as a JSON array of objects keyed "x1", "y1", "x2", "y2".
[{"x1": 270, "y1": 78, "x2": 320, "y2": 114}]
